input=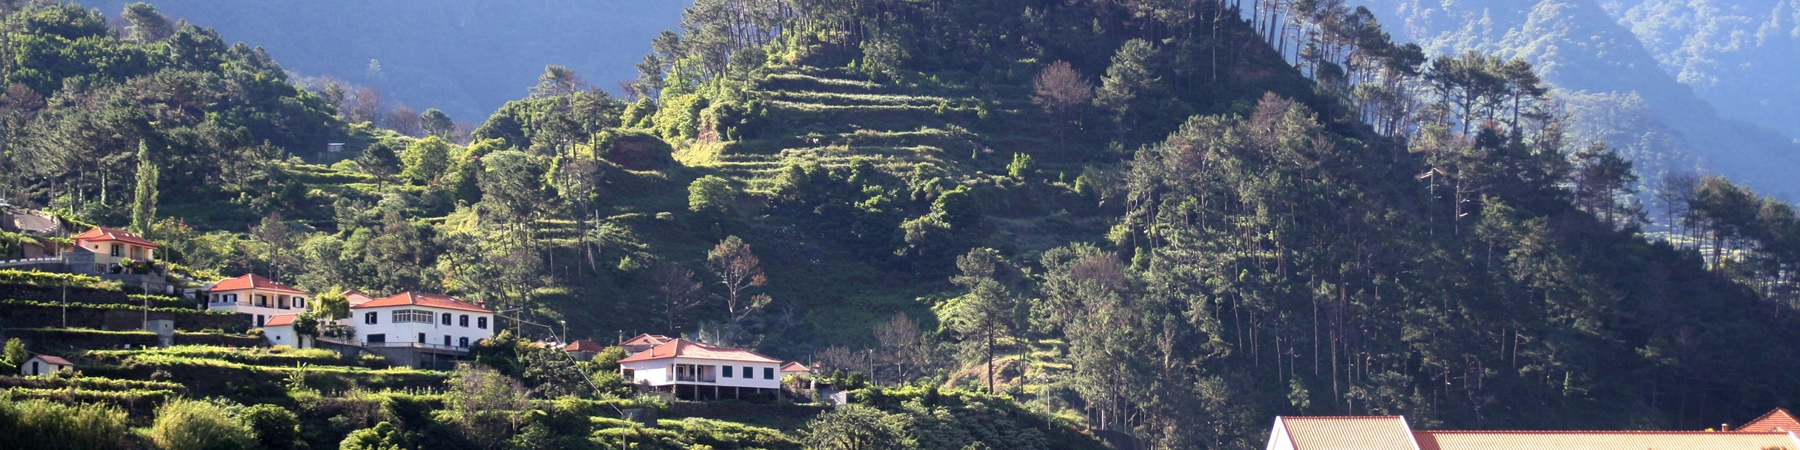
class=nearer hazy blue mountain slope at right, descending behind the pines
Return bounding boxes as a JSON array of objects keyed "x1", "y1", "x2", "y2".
[{"x1": 1354, "y1": 0, "x2": 1800, "y2": 194}]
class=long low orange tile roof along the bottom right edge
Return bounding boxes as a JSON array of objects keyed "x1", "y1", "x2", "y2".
[{"x1": 1413, "y1": 430, "x2": 1800, "y2": 450}]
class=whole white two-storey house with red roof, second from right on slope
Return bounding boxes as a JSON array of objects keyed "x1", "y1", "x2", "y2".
[{"x1": 340, "y1": 292, "x2": 495, "y2": 351}]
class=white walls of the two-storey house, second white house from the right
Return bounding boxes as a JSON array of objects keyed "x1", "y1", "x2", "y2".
[{"x1": 338, "y1": 304, "x2": 495, "y2": 347}]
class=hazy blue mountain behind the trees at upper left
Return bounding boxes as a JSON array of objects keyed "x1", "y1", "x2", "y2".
[{"x1": 86, "y1": 0, "x2": 689, "y2": 122}]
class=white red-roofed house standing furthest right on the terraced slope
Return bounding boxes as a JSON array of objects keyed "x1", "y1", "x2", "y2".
[{"x1": 619, "y1": 338, "x2": 795, "y2": 400}]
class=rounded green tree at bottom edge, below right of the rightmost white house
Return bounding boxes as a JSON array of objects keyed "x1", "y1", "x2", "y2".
[{"x1": 801, "y1": 403, "x2": 918, "y2": 450}]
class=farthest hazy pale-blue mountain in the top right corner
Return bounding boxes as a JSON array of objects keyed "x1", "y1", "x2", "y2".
[{"x1": 1602, "y1": 0, "x2": 1800, "y2": 139}]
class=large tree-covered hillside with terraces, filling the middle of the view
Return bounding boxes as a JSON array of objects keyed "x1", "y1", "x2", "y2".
[{"x1": 10, "y1": 0, "x2": 1800, "y2": 448}]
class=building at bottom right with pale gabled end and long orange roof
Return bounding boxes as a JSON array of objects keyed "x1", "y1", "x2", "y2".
[{"x1": 1267, "y1": 416, "x2": 1800, "y2": 450}]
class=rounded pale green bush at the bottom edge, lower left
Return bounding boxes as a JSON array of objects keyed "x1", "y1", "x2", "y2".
[{"x1": 149, "y1": 398, "x2": 256, "y2": 450}]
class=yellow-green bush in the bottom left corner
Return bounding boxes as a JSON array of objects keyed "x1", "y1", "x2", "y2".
[{"x1": 0, "y1": 394, "x2": 130, "y2": 450}]
